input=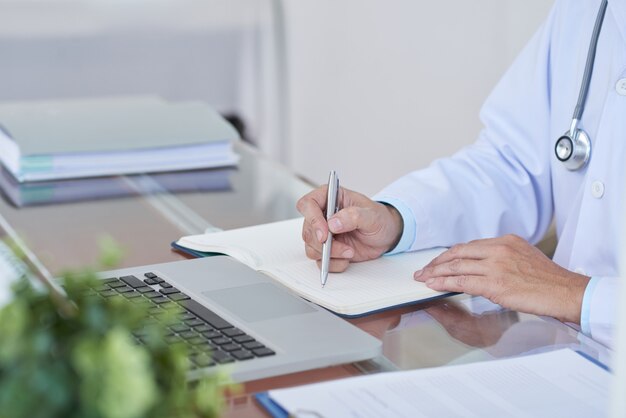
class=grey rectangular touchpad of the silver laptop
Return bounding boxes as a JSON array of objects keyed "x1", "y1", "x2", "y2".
[{"x1": 202, "y1": 283, "x2": 316, "y2": 322}]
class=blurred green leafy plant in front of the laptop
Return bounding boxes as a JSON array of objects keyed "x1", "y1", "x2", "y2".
[{"x1": 0, "y1": 238, "x2": 228, "y2": 418}]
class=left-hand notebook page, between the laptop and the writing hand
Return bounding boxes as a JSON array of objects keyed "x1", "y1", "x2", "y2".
[{"x1": 177, "y1": 218, "x2": 304, "y2": 270}]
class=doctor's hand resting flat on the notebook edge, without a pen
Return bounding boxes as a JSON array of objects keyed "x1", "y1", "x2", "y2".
[{"x1": 414, "y1": 235, "x2": 589, "y2": 324}]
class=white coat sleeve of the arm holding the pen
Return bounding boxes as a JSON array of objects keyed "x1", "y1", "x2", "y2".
[{"x1": 374, "y1": 2, "x2": 558, "y2": 251}]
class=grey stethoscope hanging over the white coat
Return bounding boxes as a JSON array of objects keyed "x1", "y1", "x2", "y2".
[{"x1": 554, "y1": 0, "x2": 607, "y2": 171}]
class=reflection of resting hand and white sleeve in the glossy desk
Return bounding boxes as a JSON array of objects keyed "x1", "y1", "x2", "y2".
[{"x1": 352, "y1": 295, "x2": 609, "y2": 372}]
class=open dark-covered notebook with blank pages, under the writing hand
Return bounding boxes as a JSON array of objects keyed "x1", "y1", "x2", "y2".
[{"x1": 172, "y1": 218, "x2": 445, "y2": 317}]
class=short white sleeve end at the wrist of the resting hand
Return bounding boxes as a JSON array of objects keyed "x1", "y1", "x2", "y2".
[{"x1": 580, "y1": 276, "x2": 620, "y2": 347}]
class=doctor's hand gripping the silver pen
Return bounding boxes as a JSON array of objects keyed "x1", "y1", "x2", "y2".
[{"x1": 297, "y1": 186, "x2": 403, "y2": 272}]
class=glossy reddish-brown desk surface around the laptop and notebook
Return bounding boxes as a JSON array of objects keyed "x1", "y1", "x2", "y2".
[{"x1": 0, "y1": 144, "x2": 609, "y2": 417}]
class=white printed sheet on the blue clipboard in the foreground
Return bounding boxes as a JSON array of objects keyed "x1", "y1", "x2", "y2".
[{"x1": 269, "y1": 349, "x2": 611, "y2": 418}]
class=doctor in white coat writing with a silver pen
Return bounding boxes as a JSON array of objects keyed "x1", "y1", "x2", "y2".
[{"x1": 298, "y1": 0, "x2": 626, "y2": 345}]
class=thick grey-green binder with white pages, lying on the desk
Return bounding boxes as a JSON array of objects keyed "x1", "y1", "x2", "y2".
[{"x1": 0, "y1": 96, "x2": 239, "y2": 183}]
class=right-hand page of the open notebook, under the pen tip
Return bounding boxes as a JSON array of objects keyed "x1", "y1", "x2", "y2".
[{"x1": 263, "y1": 248, "x2": 444, "y2": 315}]
